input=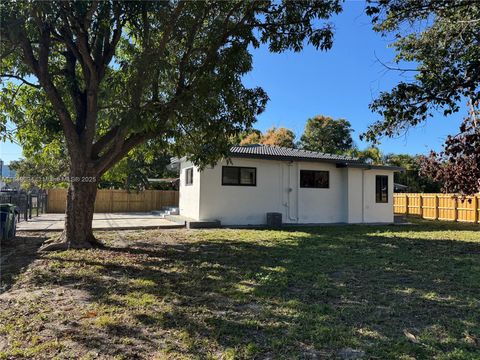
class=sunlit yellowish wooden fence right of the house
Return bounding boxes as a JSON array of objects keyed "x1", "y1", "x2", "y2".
[{"x1": 393, "y1": 193, "x2": 480, "y2": 223}]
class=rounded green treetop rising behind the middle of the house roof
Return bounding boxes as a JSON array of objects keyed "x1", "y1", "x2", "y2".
[{"x1": 300, "y1": 115, "x2": 353, "y2": 154}]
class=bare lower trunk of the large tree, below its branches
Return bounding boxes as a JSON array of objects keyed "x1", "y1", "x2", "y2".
[{"x1": 42, "y1": 177, "x2": 100, "y2": 251}]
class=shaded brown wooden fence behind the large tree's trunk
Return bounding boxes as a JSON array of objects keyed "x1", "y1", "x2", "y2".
[{"x1": 47, "y1": 189, "x2": 178, "y2": 213}]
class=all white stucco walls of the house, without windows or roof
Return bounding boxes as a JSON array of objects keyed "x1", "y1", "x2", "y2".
[{"x1": 180, "y1": 158, "x2": 393, "y2": 225}]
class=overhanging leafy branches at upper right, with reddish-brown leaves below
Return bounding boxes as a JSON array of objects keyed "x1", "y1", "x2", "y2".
[{"x1": 364, "y1": 0, "x2": 480, "y2": 194}]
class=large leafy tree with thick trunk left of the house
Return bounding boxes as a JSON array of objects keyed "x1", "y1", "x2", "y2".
[{"x1": 0, "y1": 0, "x2": 341, "y2": 249}]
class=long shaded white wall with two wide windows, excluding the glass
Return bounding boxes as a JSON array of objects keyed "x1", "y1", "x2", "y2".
[{"x1": 200, "y1": 159, "x2": 347, "y2": 225}]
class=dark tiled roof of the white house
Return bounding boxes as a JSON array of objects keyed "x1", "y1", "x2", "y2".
[{"x1": 230, "y1": 144, "x2": 403, "y2": 171}]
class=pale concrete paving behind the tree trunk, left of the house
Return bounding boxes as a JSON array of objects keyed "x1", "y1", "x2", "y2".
[{"x1": 17, "y1": 213, "x2": 184, "y2": 231}]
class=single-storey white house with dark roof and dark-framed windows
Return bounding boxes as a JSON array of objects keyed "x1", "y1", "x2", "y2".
[{"x1": 177, "y1": 145, "x2": 402, "y2": 225}]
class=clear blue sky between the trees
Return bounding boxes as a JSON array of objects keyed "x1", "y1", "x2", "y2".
[{"x1": 0, "y1": 1, "x2": 466, "y2": 163}]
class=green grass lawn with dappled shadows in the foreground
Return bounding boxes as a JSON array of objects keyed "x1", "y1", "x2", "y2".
[{"x1": 0, "y1": 218, "x2": 480, "y2": 359}]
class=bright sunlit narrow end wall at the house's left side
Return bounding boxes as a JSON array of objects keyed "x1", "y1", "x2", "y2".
[{"x1": 178, "y1": 161, "x2": 201, "y2": 220}]
